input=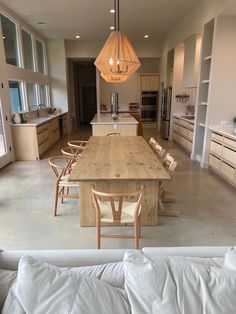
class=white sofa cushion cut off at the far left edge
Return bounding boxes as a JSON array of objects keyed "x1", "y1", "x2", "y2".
[{"x1": 0, "y1": 269, "x2": 17, "y2": 313}]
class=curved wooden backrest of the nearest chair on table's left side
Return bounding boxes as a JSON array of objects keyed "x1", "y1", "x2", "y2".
[{"x1": 48, "y1": 156, "x2": 73, "y2": 179}]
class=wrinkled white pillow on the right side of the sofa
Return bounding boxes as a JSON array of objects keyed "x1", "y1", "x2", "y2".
[{"x1": 124, "y1": 252, "x2": 236, "y2": 314}]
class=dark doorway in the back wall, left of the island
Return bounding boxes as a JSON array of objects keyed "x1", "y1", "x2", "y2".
[{"x1": 68, "y1": 59, "x2": 97, "y2": 127}]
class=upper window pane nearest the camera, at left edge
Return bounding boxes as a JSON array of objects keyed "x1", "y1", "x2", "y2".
[{"x1": 1, "y1": 14, "x2": 19, "y2": 66}]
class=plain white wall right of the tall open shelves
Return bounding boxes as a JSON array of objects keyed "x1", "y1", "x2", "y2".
[{"x1": 208, "y1": 16, "x2": 236, "y2": 125}]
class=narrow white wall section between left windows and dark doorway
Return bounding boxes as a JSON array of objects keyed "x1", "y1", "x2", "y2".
[{"x1": 48, "y1": 40, "x2": 68, "y2": 111}]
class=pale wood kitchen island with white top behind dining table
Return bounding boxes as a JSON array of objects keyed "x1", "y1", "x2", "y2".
[{"x1": 90, "y1": 113, "x2": 138, "y2": 136}]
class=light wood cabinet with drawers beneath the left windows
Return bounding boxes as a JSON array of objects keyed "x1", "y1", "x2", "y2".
[{"x1": 12, "y1": 113, "x2": 67, "y2": 160}]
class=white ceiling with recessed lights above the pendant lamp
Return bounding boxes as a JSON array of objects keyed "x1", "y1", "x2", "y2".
[{"x1": 0, "y1": 0, "x2": 197, "y2": 41}]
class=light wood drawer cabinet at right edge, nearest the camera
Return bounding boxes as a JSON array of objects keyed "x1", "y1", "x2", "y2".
[{"x1": 209, "y1": 132, "x2": 236, "y2": 186}]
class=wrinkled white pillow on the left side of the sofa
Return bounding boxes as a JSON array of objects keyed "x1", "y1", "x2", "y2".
[{"x1": 12, "y1": 256, "x2": 130, "y2": 314}]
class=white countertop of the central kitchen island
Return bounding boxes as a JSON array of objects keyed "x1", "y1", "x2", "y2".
[{"x1": 90, "y1": 113, "x2": 138, "y2": 124}]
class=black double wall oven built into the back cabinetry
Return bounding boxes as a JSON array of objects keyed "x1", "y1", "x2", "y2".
[{"x1": 141, "y1": 91, "x2": 159, "y2": 122}]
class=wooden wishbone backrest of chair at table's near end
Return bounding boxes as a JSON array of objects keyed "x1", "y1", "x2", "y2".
[{"x1": 91, "y1": 186, "x2": 143, "y2": 223}]
